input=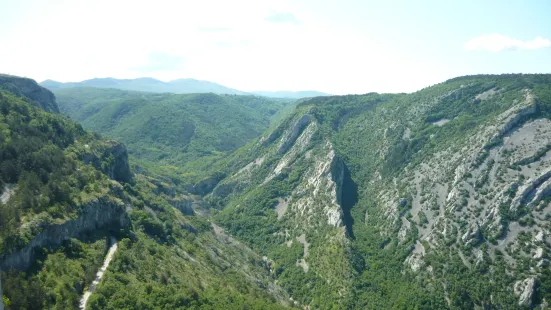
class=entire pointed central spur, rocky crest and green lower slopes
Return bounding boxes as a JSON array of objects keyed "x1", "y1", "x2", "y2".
[{"x1": 208, "y1": 109, "x2": 353, "y2": 308}]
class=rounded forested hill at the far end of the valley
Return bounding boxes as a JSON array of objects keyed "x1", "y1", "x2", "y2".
[{"x1": 51, "y1": 88, "x2": 294, "y2": 185}]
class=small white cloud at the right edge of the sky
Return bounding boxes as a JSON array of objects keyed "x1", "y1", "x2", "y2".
[{"x1": 465, "y1": 34, "x2": 551, "y2": 52}]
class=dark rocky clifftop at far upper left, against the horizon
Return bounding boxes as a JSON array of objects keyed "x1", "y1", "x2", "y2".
[{"x1": 0, "y1": 74, "x2": 59, "y2": 113}]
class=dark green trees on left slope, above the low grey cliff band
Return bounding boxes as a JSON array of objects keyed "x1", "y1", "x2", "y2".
[{"x1": 0, "y1": 92, "x2": 119, "y2": 254}]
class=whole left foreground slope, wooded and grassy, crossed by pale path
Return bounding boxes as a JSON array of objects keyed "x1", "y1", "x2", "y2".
[{"x1": 0, "y1": 77, "x2": 294, "y2": 309}]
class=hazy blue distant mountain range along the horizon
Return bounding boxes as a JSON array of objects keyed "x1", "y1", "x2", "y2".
[{"x1": 40, "y1": 77, "x2": 329, "y2": 99}]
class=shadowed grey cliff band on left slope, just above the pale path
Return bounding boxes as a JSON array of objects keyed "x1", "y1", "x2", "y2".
[{"x1": 0, "y1": 198, "x2": 130, "y2": 270}]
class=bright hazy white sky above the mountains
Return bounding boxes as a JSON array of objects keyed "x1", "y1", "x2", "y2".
[{"x1": 0, "y1": 0, "x2": 551, "y2": 94}]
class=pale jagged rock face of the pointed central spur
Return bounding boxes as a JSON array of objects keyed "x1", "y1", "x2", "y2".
[{"x1": 210, "y1": 111, "x2": 351, "y2": 300}]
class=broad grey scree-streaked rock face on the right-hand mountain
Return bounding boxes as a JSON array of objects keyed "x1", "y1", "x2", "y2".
[{"x1": 342, "y1": 78, "x2": 551, "y2": 307}]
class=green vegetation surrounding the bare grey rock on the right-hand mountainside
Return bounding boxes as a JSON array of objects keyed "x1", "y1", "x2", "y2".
[{"x1": 209, "y1": 75, "x2": 551, "y2": 309}]
